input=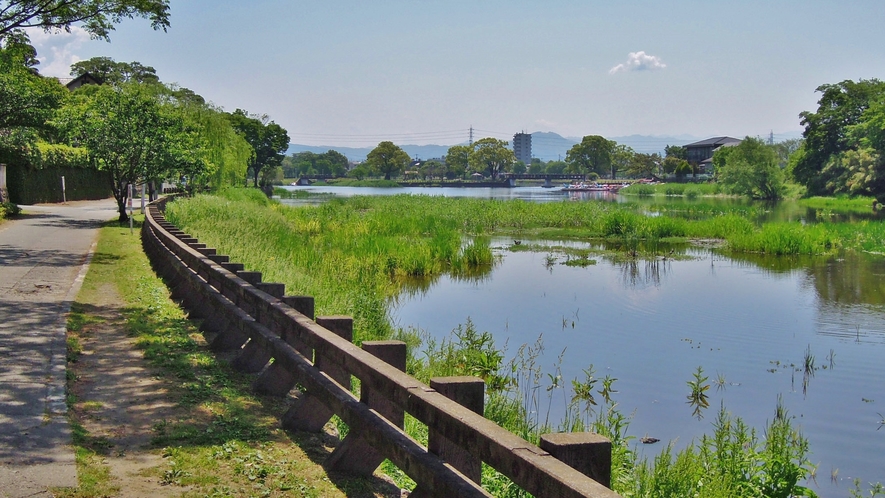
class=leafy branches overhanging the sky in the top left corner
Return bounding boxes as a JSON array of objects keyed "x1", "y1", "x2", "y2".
[{"x1": 0, "y1": 0, "x2": 169, "y2": 40}]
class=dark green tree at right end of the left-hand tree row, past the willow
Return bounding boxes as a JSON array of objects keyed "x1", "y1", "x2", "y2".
[{"x1": 228, "y1": 109, "x2": 289, "y2": 187}]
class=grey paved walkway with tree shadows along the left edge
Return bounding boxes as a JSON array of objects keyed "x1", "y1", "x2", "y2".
[{"x1": 0, "y1": 199, "x2": 117, "y2": 498}]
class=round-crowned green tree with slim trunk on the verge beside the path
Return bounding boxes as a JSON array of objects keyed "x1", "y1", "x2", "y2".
[{"x1": 58, "y1": 83, "x2": 192, "y2": 222}]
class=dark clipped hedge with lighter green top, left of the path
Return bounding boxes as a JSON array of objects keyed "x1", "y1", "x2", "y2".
[{"x1": 0, "y1": 143, "x2": 112, "y2": 204}]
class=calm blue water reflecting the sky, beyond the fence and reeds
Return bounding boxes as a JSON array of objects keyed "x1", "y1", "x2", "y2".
[{"x1": 284, "y1": 187, "x2": 885, "y2": 496}]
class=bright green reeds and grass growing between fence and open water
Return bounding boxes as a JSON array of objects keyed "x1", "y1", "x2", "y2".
[{"x1": 161, "y1": 191, "x2": 885, "y2": 496}]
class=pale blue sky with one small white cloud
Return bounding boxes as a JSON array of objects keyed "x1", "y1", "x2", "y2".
[{"x1": 25, "y1": 0, "x2": 885, "y2": 146}]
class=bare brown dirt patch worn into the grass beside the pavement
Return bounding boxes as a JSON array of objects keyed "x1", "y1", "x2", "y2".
[{"x1": 68, "y1": 284, "x2": 184, "y2": 497}]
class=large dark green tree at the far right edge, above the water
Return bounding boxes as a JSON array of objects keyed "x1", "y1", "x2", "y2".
[{"x1": 792, "y1": 79, "x2": 885, "y2": 194}]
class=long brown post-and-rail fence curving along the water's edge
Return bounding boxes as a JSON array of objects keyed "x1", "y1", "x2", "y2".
[{"x1": 142, "y1": 200, "x2": 618, "y2": 498}]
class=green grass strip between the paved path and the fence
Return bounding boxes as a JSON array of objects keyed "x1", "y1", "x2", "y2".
[{"x1": 56, "y1": 218, "x2": 398, "y2": 497}]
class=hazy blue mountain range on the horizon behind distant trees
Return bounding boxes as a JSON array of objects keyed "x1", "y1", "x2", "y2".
[{"x1": 288, "y1": 131, "x2": 802, "y2": 162}]
